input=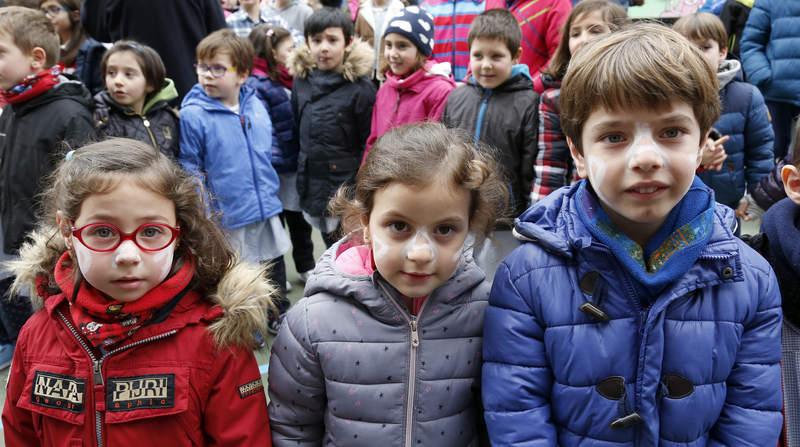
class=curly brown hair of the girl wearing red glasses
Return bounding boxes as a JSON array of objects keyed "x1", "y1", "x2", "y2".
[{"x1": 39, "y1": 138, "x2": 236, "y2": 294}]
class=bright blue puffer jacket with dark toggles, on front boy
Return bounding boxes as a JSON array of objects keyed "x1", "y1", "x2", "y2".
[{"x1": 482, "y1": 183, "x2": 782, "y2": 447}]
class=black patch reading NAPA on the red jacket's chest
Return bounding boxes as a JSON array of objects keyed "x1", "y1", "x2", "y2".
[{"x1": 31, "y1": 371, "x2": 86, "y2": 413}]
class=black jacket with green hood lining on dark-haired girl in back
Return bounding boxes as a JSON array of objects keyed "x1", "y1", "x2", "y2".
[{"x1": 94, "y1": 80, "x2": 180, "y2": 159}]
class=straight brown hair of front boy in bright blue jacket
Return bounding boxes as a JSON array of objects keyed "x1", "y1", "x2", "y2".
[{"x1": 560, "y1": 23, "x2": 720, "y2": 151}]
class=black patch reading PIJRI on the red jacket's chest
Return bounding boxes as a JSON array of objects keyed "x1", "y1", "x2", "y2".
[{"x1": 106, "y1": 374, "x2": 175, "y2": 411}]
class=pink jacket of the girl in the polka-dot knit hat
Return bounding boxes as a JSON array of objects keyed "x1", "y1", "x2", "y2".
[{"x1": 362, "y1": 61, "x2": 456, "y2": 159}]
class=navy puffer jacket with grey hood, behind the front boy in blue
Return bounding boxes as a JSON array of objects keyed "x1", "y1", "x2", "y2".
[{"x1": 700, "y1": 60, "x2": 775, "y2": 209}]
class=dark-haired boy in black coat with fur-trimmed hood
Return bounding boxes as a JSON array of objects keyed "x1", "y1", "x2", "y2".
[{"x1": 288, "y1": 7, "x2": 375, "y2": 247}]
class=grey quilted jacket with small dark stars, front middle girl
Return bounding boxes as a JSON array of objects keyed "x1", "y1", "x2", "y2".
[{"x1": 269, "y1": 238, "x2": 489, "y2": 447}]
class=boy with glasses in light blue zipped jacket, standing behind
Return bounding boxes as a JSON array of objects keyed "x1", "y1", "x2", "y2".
[{"x1": 179, "y1": 29, "x2": 290, "y2": 333}]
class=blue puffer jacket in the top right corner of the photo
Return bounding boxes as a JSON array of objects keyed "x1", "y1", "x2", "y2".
[{"x1": 741, "y1": 0, "x2": 800, "y2": 107}]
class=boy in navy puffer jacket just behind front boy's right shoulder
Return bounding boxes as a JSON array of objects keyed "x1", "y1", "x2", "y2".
[{"x1": 672, "y1": 12, "x2": 775, "y2": 220}]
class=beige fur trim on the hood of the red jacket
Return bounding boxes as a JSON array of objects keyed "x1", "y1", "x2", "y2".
[{"x1": 6, "y1": 227, "x2": 275, "y2": 346}]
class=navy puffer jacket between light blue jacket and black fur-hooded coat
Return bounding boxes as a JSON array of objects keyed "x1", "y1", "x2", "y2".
[{"x1": 246, "y1": 74, "x2": 300, "y2": 174}]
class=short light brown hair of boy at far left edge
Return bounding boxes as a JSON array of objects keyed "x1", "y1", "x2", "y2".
[{"x1": 0, "y1": 6, "x2": 61, "y2": 67}]
